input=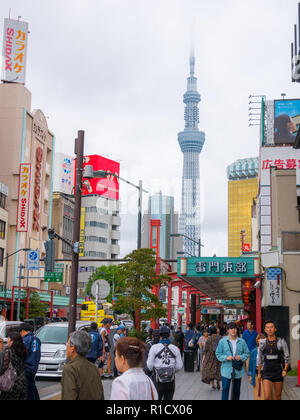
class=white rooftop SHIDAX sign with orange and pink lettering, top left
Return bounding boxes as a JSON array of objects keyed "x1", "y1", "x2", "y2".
[{"x1": 1, "y1": 19, "x2": 28, "y2": 84}]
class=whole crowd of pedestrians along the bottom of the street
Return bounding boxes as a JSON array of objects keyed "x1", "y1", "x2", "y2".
[{"x1": 0, "y1": 319, "x2": 289, "y2": 400}]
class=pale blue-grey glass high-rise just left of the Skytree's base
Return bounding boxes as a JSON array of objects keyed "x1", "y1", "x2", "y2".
[{"x1": 142, "y1": 193, "x2": 182, "y2": 259}]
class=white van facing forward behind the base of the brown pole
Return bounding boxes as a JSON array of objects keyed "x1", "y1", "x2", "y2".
[{"x1": 36, "y1": 321, "x2": 91, "y2": 378}]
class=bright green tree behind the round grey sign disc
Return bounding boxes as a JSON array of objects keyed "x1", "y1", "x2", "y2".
[{"x1": 85, "y1": 265, "x2": 125, "y2": 303}]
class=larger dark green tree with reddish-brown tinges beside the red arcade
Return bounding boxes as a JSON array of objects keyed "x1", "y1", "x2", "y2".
[{"x1": 113, "y1": 248, "x2": 168, "y2": 333}]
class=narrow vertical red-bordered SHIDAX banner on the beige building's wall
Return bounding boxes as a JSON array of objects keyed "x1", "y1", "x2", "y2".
[{"x1": 16, "y1": 163, "x2": 31, "y2": 232}]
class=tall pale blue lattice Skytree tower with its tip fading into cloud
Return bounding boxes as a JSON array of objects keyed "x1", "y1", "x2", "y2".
[{"x1": 178, "y1": 54, "x2": 205, "y2": 256}]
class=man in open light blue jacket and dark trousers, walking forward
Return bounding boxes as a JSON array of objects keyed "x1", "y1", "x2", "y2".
[{"x1": 216, "y1": 322, "x2": 250, "y2": 401}]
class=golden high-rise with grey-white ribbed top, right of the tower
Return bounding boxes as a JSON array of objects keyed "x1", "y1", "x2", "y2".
[{"x1": 227, "y1": 158, "x2": 259, "y2": 257}]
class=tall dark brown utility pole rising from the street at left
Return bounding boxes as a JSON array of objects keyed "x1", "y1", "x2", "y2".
[{"x1": 68, "y1": 131, "x2": 84, "y2": 335}]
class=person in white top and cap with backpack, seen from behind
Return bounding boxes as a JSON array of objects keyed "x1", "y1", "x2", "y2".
[{"x1": 147, "y1": 326, "x2": 183, "y2": 401}]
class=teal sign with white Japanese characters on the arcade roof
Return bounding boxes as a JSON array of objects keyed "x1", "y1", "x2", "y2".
[{"x1": 179, "y1": 257, "x2": 254, "y2": 278}]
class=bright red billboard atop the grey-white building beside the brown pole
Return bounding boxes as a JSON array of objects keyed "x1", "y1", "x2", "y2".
[{"x1": 82, "y1": 155, "x2": 120, "y2": 200}]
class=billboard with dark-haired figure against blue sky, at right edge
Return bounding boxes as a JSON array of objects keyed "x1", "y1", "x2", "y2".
[{"x1": 274, "y1": 99, "x2": 300, "y2": 145}]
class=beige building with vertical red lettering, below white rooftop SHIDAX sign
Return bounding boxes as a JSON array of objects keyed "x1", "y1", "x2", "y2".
[{"x1": 0, "y1": 83, "x2": 55, "y2": 289}]
